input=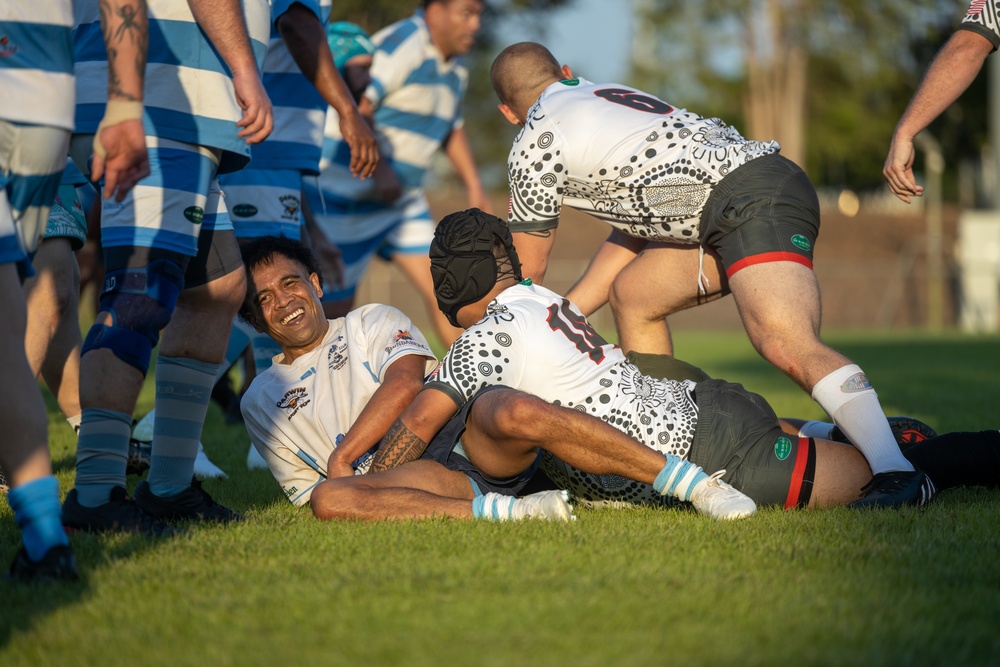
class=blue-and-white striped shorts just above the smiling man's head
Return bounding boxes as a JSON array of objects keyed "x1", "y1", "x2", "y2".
[{"x1": 219, "y1": 167, "x2": 302, "y2": 240}]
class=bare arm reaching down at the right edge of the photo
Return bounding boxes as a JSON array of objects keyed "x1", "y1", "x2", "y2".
[{"x1": 882, "y1": 30, "x2": 993, "y2": 204}]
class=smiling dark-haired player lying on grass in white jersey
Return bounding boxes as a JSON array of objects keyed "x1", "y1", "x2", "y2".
[{"x1": 241, "y1": 237, "x2": 756, "y2": 519}]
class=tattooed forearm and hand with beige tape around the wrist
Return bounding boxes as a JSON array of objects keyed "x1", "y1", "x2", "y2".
[{"x1": 91, "y1": 0, "x2": 149, "y2": 201}]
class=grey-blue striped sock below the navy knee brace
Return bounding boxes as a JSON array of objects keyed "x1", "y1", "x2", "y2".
[{"x1": 76, "y1": 408, "x2": 132, "y2": 507}]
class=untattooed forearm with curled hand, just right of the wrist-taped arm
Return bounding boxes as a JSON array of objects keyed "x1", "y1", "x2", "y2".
[{"x1": 188, "y1": 0, "x2": 274, "y2": 144}]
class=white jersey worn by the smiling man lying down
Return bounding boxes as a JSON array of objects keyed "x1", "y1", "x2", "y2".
[{"x1": 240, "y1": 304, "x2": 437, "y2": 505}]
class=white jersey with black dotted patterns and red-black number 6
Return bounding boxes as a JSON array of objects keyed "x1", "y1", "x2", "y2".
[{"x1": 507, "y1": 79, "x2": 780, "y2": 243}]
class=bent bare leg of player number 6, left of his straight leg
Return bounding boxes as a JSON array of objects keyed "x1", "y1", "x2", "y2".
[{"x1": 609, "y1": 243, "x2": 729, "y2": 354}]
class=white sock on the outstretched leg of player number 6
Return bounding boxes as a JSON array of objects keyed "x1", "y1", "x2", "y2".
[{"x1": 812, "y1": 364, "x2": 913, "y2": 474}]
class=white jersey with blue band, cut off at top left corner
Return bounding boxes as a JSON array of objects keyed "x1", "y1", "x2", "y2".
[{"x1": 0, "y1": 0, "x2": 74, "y2": 130}]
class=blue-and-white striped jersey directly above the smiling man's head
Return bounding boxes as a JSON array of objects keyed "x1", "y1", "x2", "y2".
[{"x1": 250, "y1": 0, "x2": 332, "y2": 174}]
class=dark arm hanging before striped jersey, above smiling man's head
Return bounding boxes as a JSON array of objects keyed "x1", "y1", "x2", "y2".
[{"x1": 276, "y1": 4, "x2": 378, "y2": 179}]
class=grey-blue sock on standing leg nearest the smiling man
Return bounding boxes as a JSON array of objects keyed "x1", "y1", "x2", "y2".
[{"x1": 146, "y1": 356, "x2": 219, "y2": 498}]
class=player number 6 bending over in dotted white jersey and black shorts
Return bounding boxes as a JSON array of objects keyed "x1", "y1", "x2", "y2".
[{"x1": 490, "y1": 42, "x2": 933, "y2": 506}]
